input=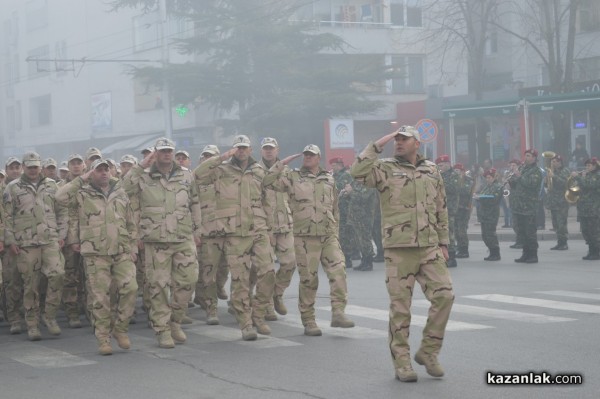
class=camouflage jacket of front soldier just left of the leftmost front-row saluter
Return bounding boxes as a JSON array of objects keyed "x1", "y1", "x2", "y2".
[{"x1": 4, "y1": 175, "x2": 67, "y2": 247}]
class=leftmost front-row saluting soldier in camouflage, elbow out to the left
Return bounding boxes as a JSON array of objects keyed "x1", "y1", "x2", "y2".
[{"x1": 56, "y1": 159, "x2": 137, "y2": 355}]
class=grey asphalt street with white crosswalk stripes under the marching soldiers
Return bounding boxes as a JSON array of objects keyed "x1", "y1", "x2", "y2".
[{"x1": 0, "y1": 240, "x2": 600, "y2": 399}]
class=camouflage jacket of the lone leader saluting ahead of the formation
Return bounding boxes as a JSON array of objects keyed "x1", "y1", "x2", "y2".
[{"x1": 350, "y1": 142, "x2": 448, "y2": 248}]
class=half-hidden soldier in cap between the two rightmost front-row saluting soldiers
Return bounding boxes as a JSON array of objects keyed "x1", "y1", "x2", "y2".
[{"x1": 260, "y1": 137, "x2": 296, "y2": 320}]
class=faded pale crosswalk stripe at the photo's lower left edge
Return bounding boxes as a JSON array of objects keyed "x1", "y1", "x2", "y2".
[{"x1": 2, "y1": 344, "x2": 97, "y2": 369}]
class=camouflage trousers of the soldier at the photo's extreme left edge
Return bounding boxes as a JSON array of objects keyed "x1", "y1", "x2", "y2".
[{"x1": 2, "y1": 253, "x2": 23, "y2": 323}]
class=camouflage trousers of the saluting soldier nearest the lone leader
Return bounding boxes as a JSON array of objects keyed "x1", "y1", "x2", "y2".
[{"x1": 294, "y1": 235, "x2": 348, "y2": 325}]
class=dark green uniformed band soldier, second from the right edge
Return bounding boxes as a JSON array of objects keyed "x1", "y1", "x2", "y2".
[{"x1": 544, "y1": 154, "x2": 571, "y2": 251}]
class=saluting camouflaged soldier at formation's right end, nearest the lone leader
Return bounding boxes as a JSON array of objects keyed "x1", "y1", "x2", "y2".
[{"x1": 264, "y1": 144, "x2": 354, "y2": 336}]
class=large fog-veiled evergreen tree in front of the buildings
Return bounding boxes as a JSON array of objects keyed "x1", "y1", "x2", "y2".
[{"x1": 113, "y1": 0, "x2": 385, "y2": 147}]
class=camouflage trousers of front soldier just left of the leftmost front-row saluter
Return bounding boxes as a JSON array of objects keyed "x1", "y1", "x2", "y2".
[{"x1": 17, "y1": 243, "x2": 65, "y2": 328}]
